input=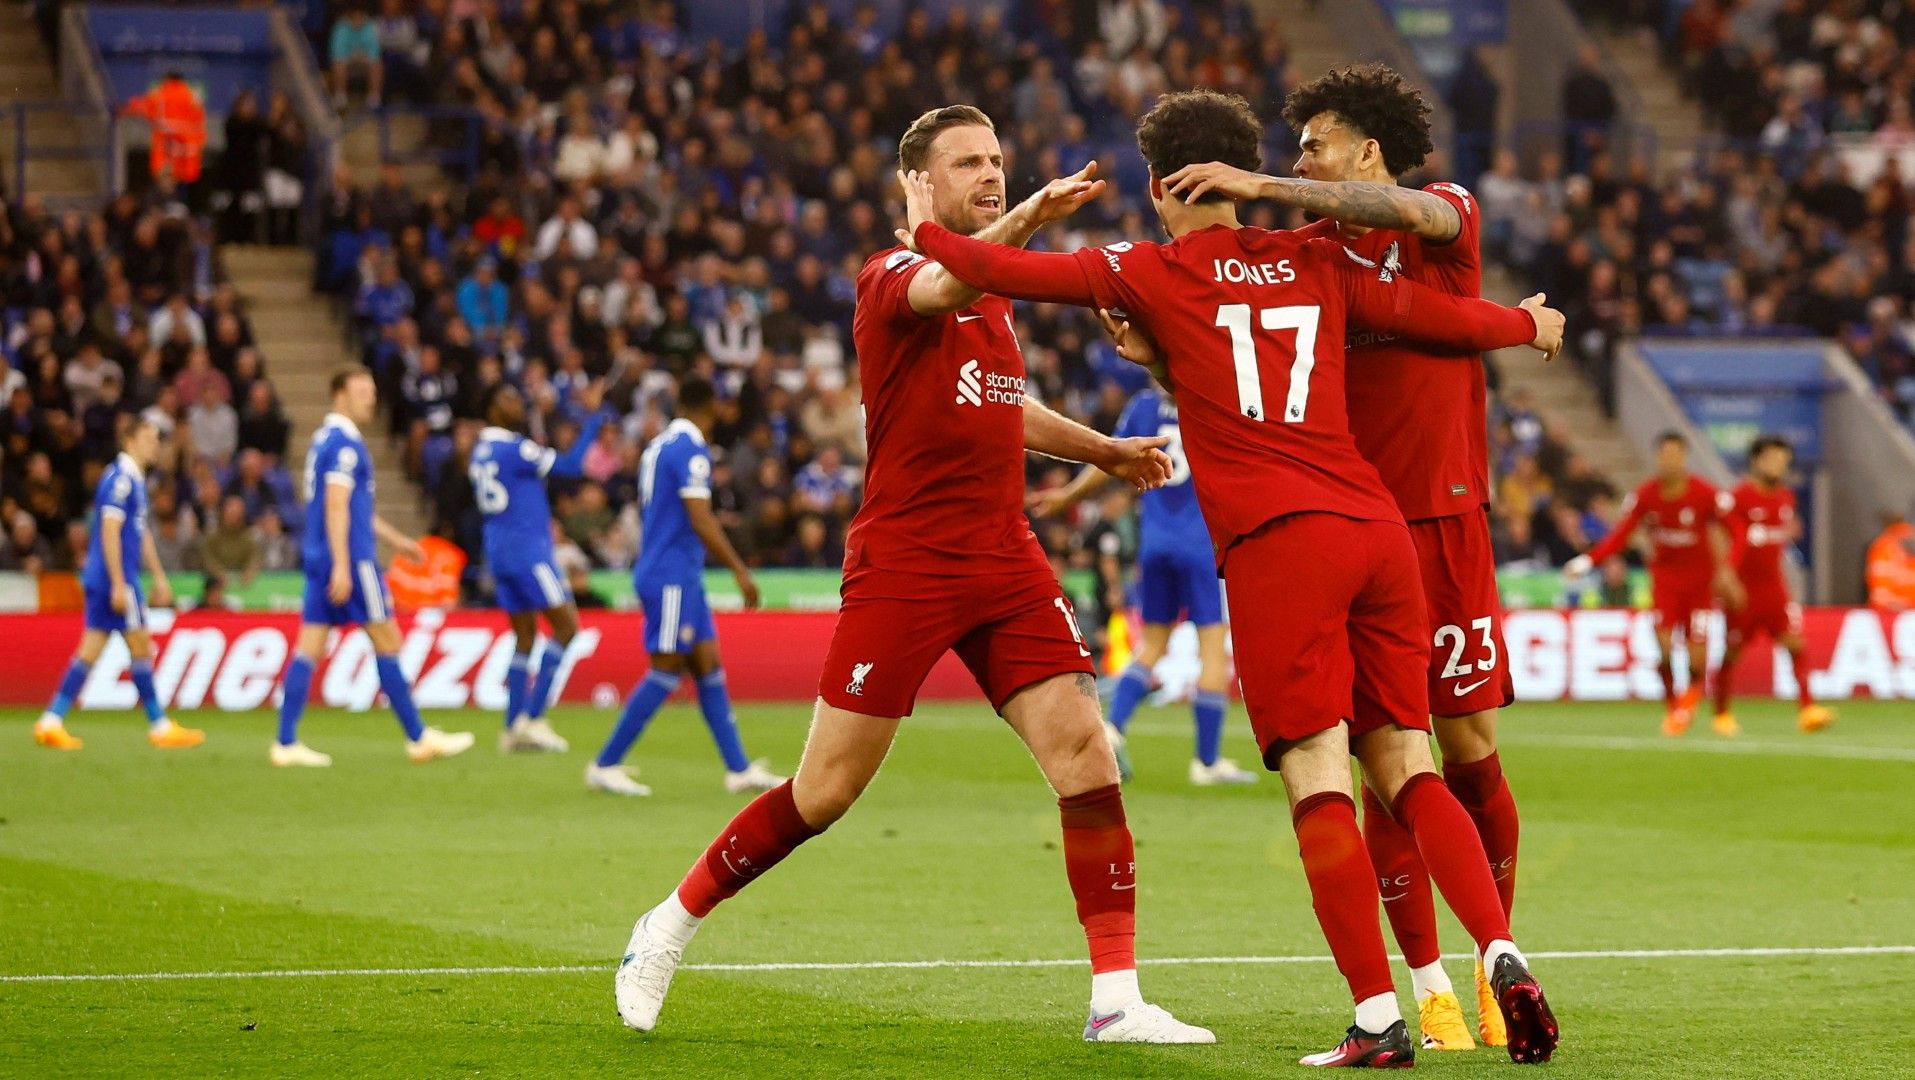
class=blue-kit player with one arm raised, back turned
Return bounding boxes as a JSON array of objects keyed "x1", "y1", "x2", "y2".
[{"x1": 467, "y1": 383, "x2": 605, "y2": 753}]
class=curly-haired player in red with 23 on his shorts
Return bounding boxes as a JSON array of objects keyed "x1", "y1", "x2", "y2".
[{"x1": 1164, "y1": 65, "x2": 1519, "y2": 1049}]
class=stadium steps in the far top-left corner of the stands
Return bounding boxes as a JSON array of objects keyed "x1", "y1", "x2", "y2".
[{"x1": 0, "y1": 4, "x2": 103, "y2": 209}]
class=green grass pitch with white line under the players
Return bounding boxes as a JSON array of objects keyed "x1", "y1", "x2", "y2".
[{"x1": 0, "y1": 703, "x2": 1915, "y2": 1078}]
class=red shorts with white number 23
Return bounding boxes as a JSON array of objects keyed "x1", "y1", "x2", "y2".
[{"x1": 1409, "y1": 509, "x2": 1517, "y2": 716}]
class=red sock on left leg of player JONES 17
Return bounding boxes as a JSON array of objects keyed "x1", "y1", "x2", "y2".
[{"x1": 1291, "y1": 791, "x2": 1396, "y2": 1001}]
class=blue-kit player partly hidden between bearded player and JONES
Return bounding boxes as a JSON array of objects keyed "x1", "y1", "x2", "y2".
[{"x1": 1030, "y1": 387, "x2": 1256, "y2": 787}]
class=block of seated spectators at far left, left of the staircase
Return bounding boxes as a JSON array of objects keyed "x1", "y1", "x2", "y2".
[{"x1": 0, "y1": 190, "x2": 301, "y2": 578}]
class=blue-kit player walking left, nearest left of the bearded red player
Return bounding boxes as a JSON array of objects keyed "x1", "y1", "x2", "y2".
[{"x1": 586, "y1": 375, "x2": 785, "y2": 795}]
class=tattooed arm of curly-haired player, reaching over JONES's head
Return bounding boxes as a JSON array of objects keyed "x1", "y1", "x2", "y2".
[{"x1": 1164, "y1": 161, "x2": 1463, "y2": 243}]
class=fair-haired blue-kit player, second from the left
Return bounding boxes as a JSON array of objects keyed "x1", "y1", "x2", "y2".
[{"x1": 270, "y1": 366, "x2": 473, "y2": 768}]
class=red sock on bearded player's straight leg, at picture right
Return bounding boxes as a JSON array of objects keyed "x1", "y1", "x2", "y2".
[{"x1": 1057, "y1": 783, "x2": 1138, "y2": 975}]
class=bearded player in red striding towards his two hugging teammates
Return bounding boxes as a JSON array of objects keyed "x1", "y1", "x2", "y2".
[{"x1": 615, "y1": 105, "x2": 1216, "y2": 1044}]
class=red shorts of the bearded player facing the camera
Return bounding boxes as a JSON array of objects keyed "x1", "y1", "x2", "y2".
[{"x1": 818, "y1": 559, "x2": 1095, "y2": 716}]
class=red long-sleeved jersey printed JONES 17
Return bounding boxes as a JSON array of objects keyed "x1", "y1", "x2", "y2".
[{"x1": 900, "y1": 224, "x2": 1536, "y2": 563}]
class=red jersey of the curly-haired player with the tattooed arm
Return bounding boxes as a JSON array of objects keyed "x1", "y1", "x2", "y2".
[{"x1": 1296, "y1": 184, "x2": 1490, "y2": 521}]
